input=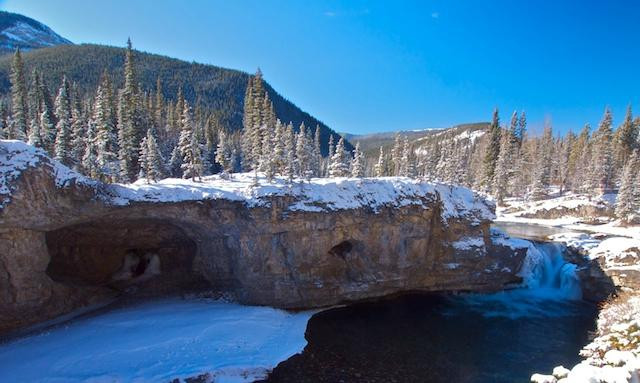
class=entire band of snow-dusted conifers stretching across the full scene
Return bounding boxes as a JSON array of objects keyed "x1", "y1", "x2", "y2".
[{"x1": 0, "y1": 41, "x2": 640, "y2": 219}]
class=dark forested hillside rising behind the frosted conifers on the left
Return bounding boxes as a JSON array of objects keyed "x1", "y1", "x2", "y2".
[{"x1": 0, "y1": 44, "x2": 352, "y2": 155}]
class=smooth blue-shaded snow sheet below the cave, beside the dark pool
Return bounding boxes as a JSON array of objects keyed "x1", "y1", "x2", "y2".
[{"x1": 0, "y1": 299, "x2": 313, "y2": 383}]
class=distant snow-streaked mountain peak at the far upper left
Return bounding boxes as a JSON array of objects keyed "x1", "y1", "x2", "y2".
[{"x1": 0, "y1": 11, "x2": 72, "y2": 54}]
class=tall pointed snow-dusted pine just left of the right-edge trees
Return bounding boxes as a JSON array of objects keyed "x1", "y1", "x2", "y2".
[{"x1": 590, "y1": 108, "x2": 614, "y2": 195}]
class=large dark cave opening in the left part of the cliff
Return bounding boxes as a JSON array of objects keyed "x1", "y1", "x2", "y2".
[{"x1": 46, "y1": 220, "x2": 197, "y2": 290}]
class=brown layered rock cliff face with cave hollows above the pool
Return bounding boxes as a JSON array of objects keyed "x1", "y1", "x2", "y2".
[{"x1": 0, "y1": 145, "x2": 526, "y2": 332}]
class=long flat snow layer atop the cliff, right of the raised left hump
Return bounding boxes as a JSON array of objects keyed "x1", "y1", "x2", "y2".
[{"x1": 110, "y1": 173, "x2": 494, "y2": 221}]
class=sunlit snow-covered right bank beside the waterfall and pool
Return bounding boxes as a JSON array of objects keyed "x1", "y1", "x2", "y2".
[{"x1": 495, "y1": 199, "x2": 640, "y2": 383}]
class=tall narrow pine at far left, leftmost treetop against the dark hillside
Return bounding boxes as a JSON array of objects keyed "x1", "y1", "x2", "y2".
[{"x1": 9, "y1": 48, "x2": 29, "y2": 141}]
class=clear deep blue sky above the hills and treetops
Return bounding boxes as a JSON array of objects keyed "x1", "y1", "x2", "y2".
[{"x1": 0, "y1": 0, "x2": 640, "y2": 133}]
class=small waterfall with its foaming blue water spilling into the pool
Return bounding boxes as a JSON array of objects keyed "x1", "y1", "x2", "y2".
[{"x1": 462, "y1": 243, "x2": 582, "y2": 319}]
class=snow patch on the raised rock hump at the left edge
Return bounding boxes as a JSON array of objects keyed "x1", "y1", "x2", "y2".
[{"x1": 0, "y1": 140, "x2": 97, "y2": 208}]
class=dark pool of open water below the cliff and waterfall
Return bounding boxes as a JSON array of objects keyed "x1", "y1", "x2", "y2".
[{"x1": 258, "y1": 295, "x2": 597, "y2": 383}]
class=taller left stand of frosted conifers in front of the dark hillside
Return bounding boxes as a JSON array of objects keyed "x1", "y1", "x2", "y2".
[{"x1": 0, "y1": 41, "x2": 362, "y2": 183}]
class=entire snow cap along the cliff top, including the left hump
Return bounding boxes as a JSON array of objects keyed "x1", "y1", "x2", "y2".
[{"x1": 0, "y1": 140, "x2": 494, "y2": 224}]
